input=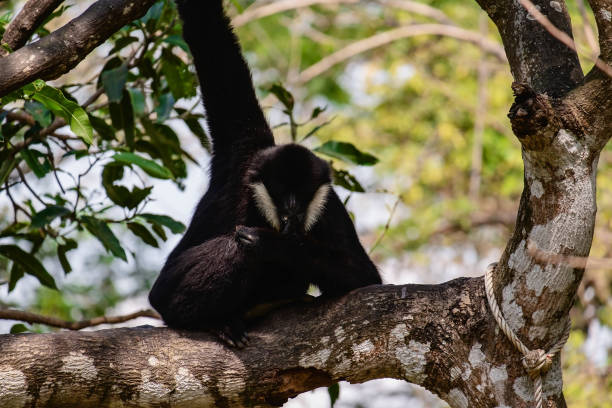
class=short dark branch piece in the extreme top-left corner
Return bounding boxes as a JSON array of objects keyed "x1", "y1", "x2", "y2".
[{"x1": 0, "y1": 0, "x2": 64, "y2": 57}]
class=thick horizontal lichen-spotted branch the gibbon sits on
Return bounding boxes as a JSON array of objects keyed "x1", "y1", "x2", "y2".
[{"x1": 0, "y1": 278, "x2": 560, "y2": 408}]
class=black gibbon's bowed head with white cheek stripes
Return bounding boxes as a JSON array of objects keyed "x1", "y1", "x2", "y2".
[{"x1": 248, "y1": 144, "x2": 331, "y2": 234}]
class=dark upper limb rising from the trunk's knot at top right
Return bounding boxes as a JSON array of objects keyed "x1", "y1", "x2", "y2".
[{"x1": 477, "y1": 0, "x2": 583, "y2": 96}]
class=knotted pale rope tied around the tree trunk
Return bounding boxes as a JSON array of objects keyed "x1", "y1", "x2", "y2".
[{"x1": 485, "y1": 263, "x2": 571, "y2": 408}]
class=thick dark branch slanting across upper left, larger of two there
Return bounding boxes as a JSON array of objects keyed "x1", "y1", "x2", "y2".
[{"x1": 0, "y1": 0, "x2": 155, "y2": 96}]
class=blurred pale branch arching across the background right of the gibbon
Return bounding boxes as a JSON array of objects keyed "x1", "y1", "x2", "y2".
[{"x1": 297, "y1": 24, "x2": 506, "y2": 83}]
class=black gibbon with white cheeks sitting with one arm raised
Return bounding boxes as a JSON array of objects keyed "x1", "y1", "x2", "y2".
[{"x1": 149, "y1": 0, "x2": 381, "y2": 347}]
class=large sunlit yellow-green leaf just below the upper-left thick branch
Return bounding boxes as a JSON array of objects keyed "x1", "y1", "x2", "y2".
[{"x1": 26, "y1": 84, "x2": 93, "y2": 144}]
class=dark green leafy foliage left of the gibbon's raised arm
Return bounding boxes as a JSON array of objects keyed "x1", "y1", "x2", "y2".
[{"x1": 0, "y1": 0, "x2": 191, "y2": 289}]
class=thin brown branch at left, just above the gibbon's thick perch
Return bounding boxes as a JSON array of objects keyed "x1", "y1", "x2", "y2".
[{"x1": 0, "y1": 309, "x2": 161, "y2": 330}]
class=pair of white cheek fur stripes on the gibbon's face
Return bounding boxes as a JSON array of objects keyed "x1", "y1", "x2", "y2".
[{"x1": 251, "y1": 183, "x2": 331, "y2": 232}]
